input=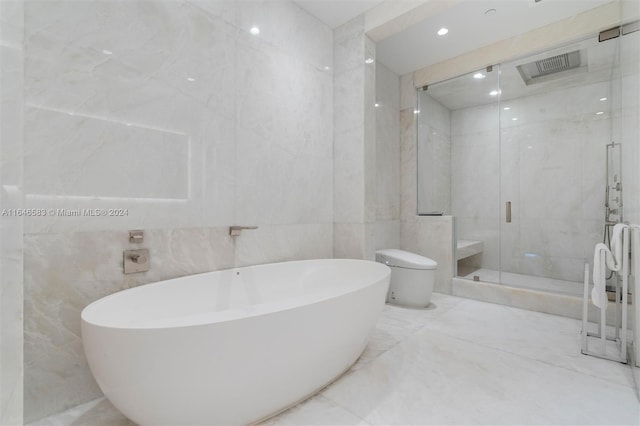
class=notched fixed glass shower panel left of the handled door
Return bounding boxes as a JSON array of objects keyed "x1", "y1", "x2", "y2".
[{"x1": 417, "y1": 66, "x2": 500, "y2": 282}]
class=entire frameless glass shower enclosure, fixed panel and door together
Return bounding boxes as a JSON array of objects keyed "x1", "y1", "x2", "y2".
[{"x1": 417, "y1": 25, "x2": 640, "y2": 295}]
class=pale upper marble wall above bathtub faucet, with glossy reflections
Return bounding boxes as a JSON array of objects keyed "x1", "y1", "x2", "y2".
[{"x1": 25, "y1": 1, "x2": 333, "y2": 232}]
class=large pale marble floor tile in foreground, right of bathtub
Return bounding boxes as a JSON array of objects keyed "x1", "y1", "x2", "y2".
[{"x1": 322, "y1": 329, "x2": 640, "y2": 425}]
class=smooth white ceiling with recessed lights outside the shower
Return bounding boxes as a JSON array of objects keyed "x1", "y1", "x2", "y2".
[{"x1": 297, "y1": 0, "x2": 611, "y2": 75}]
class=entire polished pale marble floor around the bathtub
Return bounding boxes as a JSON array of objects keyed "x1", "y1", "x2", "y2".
[{"x1": 34, "y1": 294, "x2": 640, "y2": 426}]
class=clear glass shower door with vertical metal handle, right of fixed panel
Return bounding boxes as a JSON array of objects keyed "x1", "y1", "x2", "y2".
[{"x1": 500, "y1": 36, "x2": 629, "y2": 295}]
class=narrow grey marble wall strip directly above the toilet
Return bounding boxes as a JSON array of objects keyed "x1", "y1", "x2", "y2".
[{"x1": 375, "y1": 62, "x2": 400, "y2": 249}]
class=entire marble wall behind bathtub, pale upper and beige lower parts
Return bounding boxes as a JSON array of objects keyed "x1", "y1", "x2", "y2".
[{"x1": 21, "y1": 0, "x2": 336, "y2": 422}]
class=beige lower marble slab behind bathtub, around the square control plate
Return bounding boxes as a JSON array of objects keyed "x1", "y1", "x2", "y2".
[{"x1": 24, "y1": 228, "x2": 234, "y2": 422}]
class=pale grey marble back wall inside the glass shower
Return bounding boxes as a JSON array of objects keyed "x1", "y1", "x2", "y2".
[{"x1": 451, "y1": 82, "x2": 632, "y2": 281}]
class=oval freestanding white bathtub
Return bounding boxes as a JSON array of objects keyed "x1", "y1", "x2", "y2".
[{"x1": 82, "y1": 259, "x2": 390, "y2": 425}]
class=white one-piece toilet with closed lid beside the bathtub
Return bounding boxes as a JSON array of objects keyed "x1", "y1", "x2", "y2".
[{"x1": 376, "y1": 249, "x2": 438, "y2": 308}]
